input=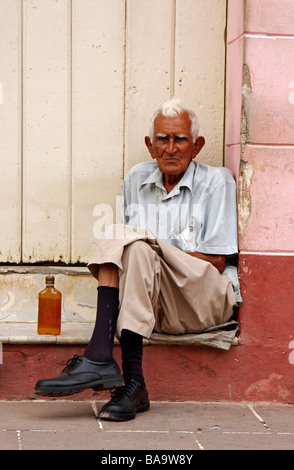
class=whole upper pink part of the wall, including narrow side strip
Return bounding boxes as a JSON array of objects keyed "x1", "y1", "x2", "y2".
[{"x1": 226, "y1": 0, "x2": 294, "y2": 252}]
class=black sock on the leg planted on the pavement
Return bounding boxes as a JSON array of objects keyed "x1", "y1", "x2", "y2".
[{"x1": 120, "y1": 330, "x2": 145, "y2": 385}]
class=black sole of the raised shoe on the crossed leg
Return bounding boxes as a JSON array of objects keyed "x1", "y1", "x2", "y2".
[{"x1": 34, "y1": 376, "x2": 124, "y2": 397}]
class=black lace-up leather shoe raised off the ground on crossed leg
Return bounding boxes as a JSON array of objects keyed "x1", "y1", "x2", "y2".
[{"x1": 35, "y1": 354, "x2": 124, "y2": 397}]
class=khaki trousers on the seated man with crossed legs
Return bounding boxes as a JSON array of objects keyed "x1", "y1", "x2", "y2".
[{"x1": 88, "y1": 224, "x2": 236, "y2": 338}]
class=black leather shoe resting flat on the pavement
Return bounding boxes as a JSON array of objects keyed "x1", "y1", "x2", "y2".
[{"x1": 99, "y1": 379, "x2": 150, "y2": 421}]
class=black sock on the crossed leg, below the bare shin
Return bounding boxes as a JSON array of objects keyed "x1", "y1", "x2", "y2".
[{"x1": 84, "y1": 286, "x2": 119, "y2": 362}]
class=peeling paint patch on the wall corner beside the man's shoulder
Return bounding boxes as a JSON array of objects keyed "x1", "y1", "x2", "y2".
[{"x1": 238, "y1": 160, "x2": 253, "y2": 235}]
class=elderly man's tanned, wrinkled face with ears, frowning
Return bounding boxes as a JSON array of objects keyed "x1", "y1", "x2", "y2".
[{"x1": 145, "y1": 113, "x2": 205, "y2": 176}]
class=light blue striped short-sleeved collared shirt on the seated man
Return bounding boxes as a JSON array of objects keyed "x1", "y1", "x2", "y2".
[{"x1": 122, "y1": 160, "x2": 241, "y2": 303}]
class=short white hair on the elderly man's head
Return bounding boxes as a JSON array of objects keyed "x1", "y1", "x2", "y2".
[{"x1": 149, "y1": 98, "x2": 199, "y2": 142}]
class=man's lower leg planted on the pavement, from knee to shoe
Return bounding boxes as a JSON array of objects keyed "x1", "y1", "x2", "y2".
[{"x1": 99, "y1": 241, "x2": 160, "y2": 421}]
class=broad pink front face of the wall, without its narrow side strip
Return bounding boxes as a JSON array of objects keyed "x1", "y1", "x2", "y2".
[{"x1": 240, "y1": 0, "x2": 294, "y2": 252}]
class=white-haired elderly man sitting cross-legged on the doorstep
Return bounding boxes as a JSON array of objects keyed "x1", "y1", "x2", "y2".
[{"x1": 35, "y1": 99, "x2": 239, "y2": 420}]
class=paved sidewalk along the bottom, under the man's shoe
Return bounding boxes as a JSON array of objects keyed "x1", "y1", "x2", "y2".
[{"x1": 0, "y1": 400, "x2": 294, "y2": 455}]
